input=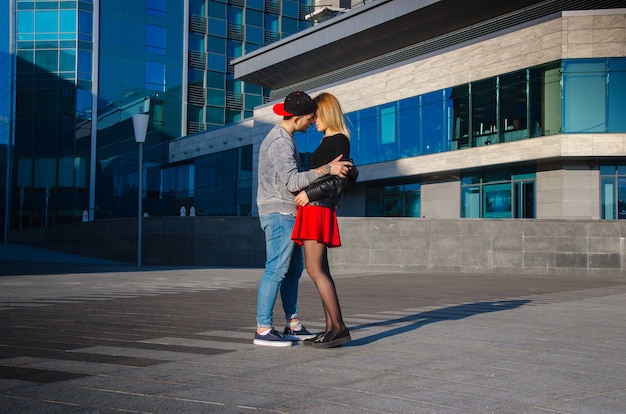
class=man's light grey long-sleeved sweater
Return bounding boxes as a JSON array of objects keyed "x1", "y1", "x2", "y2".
[{"x1": 256, "y1": 124, "x2": 317, "y2": 216}]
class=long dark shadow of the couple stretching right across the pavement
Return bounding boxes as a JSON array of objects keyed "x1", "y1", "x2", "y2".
[{"x1": 343, "y1": 299, "x2": 531, "y2": 347}]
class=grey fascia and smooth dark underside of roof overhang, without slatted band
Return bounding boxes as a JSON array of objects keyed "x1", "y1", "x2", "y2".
[{"x1": 232, "y1": 0, "x2": 538, "y2": 94}]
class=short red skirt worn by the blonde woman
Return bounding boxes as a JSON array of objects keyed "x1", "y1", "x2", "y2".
[{"x1": 291, "y1": 205, "x2": 341, "y2": 247}]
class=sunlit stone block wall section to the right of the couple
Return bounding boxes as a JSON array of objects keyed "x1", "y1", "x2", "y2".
[{"x1": 329, "y1": 217, "x2": 626, "y2": 276}]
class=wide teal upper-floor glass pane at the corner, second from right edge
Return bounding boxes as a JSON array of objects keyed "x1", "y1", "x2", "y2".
[{"x1": 563, "y1": 59, "x2": 607, "y2": 133}]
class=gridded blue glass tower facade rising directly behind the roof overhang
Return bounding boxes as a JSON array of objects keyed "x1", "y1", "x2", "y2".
[{"x1": 187, "y1": 0, "x2": 313, "y2": 134}]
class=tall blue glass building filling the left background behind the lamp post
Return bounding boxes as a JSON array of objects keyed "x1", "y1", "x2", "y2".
[{"x1": 0, "y1": 0, "x2": 312, "y2": 238}]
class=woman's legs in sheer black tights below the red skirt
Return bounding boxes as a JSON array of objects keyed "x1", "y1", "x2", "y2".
[{"x1": 303, "y1": 240, "x2": 346, "y2": 333}]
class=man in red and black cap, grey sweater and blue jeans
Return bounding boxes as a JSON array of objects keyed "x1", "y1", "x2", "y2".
[{"x1": 254, "y1": 91, "x2": 351, "y2": 346}]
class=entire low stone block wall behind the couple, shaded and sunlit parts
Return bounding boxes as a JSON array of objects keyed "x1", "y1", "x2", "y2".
[{"x1": 8, "y1": 217, "x2": 626, "y2": 276}]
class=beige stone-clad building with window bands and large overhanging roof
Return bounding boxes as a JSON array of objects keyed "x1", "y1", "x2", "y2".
[{"x1": 170, "y1": 0, "x2": 626, "y2": 220}]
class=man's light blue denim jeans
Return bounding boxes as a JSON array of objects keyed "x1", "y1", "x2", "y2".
[{"x1": 256, "y1": 213, "x2": 304, "y2": 328}]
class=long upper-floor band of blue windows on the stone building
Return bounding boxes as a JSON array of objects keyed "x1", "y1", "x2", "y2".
[{"x1": 346, "y1": 58, "x2": 626, "y2": 168}]
